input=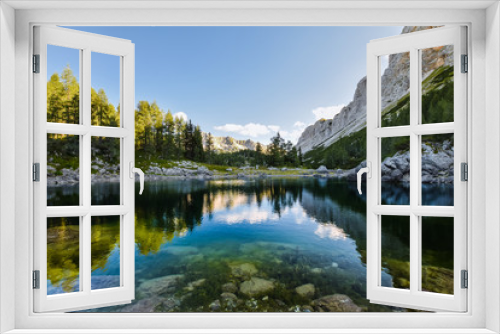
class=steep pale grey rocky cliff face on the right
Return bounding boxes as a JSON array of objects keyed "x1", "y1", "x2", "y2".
[{"x1": 297, "y1": 26, "x2": 453, "y2": 153}]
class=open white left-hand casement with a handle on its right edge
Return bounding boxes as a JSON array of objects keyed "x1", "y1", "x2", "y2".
[{"x1": 33, "y1": 26, "x2": 139, "y2": 312}]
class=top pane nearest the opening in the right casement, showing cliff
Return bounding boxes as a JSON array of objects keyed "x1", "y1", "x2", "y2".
[{"x1": 380, "y1": 52, "x2": 410, "y2": 127}]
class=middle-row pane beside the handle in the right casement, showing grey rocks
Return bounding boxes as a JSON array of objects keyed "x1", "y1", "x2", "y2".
[{"x1": 380, "y1": 137, "x2": 410, "y2": 205}]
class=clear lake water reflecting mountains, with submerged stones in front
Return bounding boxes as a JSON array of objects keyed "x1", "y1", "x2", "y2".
[{"x1": 48, "y1": 178, "x2": 453, "y2": 312}]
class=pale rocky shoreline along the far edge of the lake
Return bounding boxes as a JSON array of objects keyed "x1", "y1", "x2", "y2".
[{"x1": 47, "y1": 142, "x2": 454, "y2": 186}]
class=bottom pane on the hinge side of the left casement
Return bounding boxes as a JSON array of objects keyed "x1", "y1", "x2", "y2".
[{"x1": 47, "y1": 217, "x2": 80, "y2": 295}]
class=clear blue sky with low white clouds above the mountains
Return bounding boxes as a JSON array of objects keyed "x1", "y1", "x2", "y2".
[{"x1": 48, "y1": 27, "x2": 402, "y2": 143}]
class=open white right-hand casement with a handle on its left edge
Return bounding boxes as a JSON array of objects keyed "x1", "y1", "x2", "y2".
[{"x1": 367, "y1": 26, "x2": 467, "y2": 312}]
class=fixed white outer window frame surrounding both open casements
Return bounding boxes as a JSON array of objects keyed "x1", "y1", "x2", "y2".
[{"x1": 0, "y1": 1, "x2": 500, "y2": 333}]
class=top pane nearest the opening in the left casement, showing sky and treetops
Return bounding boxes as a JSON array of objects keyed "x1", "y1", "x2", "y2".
[{"x1": 91, "y1": 52, "x2": 120, "y2": 126}]
